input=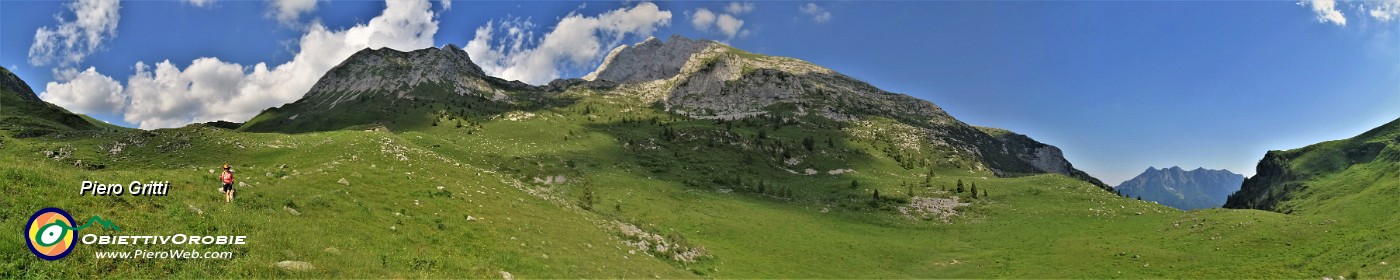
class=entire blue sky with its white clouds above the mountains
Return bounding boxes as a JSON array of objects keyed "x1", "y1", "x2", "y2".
[{"x1": 0, "y1": 0, "x2": 1400, "y2": 185}]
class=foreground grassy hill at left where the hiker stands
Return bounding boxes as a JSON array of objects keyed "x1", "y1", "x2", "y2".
[{"x1": 0, "y1": 129, "x2": 685, "y2": 277}]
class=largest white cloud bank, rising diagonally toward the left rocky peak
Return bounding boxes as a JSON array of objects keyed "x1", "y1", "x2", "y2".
[{"x1": 45, "y1": 0, "x2": 438, "y2": 129}]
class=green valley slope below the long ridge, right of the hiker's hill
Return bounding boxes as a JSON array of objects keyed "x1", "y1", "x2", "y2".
[{"x1": 389, "y1": 91, "x2": 1393, "y2": 277}]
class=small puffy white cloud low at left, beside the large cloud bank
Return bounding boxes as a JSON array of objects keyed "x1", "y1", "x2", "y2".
[{"x1": 39, "y1": 67, "x2": 126, "y2": 115}]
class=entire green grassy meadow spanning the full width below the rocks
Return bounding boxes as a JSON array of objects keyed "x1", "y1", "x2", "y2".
[{"x1": 0, "y1": 90, "x2": 1400, "y2": 277}]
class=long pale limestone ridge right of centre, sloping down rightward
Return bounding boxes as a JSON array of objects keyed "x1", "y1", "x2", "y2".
[{"x1": 574, "y1": 36, "x2": 1107, "y2": 189}]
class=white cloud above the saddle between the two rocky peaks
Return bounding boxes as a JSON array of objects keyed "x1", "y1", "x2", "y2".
[{"x1": 463, "y1": 3, "x2": 671, "y2": 84}]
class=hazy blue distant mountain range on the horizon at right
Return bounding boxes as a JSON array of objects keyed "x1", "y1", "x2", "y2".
[{"x1": 1113, "y1": 167, "x2": 1245, "y2": 210}]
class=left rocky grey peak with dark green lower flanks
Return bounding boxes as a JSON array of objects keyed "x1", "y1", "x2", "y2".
[{"x1": 239, "y1": 45, "x2": 543, "y2": 132}]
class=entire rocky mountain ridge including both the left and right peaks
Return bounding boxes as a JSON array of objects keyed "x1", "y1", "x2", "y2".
[{"x1": 242, "y1": 36, "x2": 1107, "y2": 188}]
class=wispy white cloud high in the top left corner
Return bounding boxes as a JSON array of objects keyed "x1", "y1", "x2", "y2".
[{"x1": 29, "y1": 0, "x2": 122, "y2": 66}]
